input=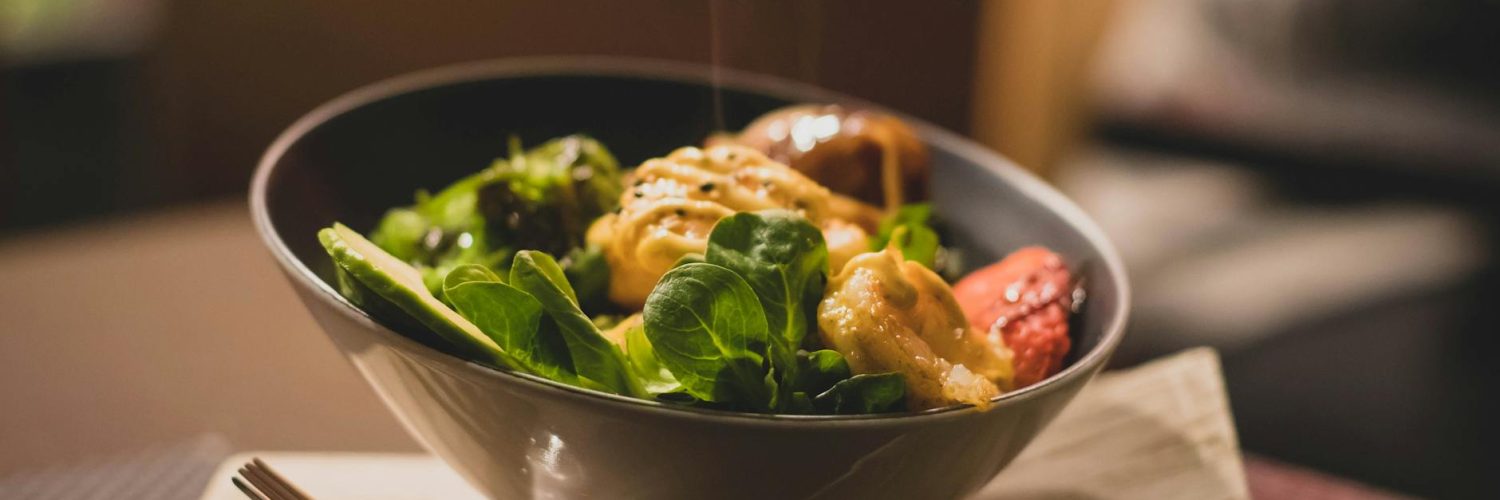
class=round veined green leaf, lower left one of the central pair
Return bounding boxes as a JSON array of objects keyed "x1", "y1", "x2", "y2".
[{"x1": 644, "y1": 263, "x2": 774, "y2": 411}]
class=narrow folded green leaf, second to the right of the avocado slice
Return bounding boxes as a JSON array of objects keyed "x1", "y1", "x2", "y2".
[{"x1": 510, "y1": 251, "x2": 642, "y2": 395}]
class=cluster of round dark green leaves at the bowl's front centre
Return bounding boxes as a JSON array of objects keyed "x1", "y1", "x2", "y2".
[{"x1": 645, "y1": 210, "x2": 906, "y2": 413}]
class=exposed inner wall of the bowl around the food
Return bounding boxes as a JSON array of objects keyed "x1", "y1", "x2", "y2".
[{"x1": 263, "y1": 62, "x2": 1124, "y2": 405}]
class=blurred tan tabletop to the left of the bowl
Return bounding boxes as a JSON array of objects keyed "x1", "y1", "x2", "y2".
[{"x1": 0, "y1": 200, "x2": 419, "y2": 474}]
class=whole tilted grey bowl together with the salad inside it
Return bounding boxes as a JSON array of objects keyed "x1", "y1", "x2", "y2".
[{"x1": 251, "y1": 57, "x2": 1130, "y2": 498}]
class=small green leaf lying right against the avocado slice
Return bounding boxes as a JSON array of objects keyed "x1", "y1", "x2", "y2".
[{"x1": 443, "y1": 264, "x2": 578, "y2": 384}]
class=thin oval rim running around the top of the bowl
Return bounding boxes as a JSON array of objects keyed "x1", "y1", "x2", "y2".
[{"x1": 249, "y1": 56, "x2": 1131, "y2": 426}]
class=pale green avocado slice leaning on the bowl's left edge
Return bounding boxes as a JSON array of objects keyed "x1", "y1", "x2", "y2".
[{"x1": 318, "y1": 222, "x2": 518, "y2": 368}]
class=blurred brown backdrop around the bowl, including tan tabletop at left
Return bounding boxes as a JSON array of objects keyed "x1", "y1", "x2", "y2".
[{"x1": 0, "y1": 0, "x2": 1500, "y2": 497}]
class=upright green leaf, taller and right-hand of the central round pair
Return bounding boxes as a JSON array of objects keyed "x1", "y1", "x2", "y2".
[{"x1": 705, "y1": 210, "x2": 828, "y2": 402}]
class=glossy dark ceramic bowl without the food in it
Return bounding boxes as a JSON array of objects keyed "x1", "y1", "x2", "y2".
[{"x1": 251, "y1": 59, "x2": 1130, "y2": 498}]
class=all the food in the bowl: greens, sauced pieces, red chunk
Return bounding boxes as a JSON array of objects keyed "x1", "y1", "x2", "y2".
[{"x1": 318, "y1": 105, "x2": 1083, "y2": 414}]
